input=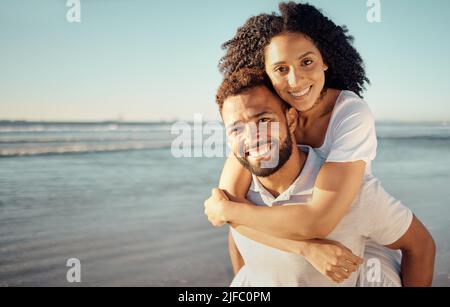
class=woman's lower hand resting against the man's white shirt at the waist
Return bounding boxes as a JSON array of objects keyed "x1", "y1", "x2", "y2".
[{"x1": 301, "y1": 240, "x2": 364, "y2": 283}]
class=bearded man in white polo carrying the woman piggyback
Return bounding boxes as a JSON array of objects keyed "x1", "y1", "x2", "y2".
[{"x1": 205, "y1": 70, "x2": 435, "y2": 286}]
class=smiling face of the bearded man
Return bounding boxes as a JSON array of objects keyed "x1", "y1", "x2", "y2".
[{"x1": 222, "y1": 86, "x2": 292, "y2": 177}]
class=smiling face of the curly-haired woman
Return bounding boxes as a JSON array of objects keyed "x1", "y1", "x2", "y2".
[{"x1": 264, "y1": 33, "x2": 328, "y2": 112}]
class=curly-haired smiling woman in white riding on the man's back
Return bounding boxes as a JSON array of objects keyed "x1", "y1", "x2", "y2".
[{"x1": 205, "y1": 2, "x2": 401, "y2": 286}]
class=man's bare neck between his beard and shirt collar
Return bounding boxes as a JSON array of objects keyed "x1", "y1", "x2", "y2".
[{"x1": 258, "y1": 145, "x2": 307, "y2": 197}]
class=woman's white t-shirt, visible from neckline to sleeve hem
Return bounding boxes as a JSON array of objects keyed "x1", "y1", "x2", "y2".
[{"x1": 315, "y1": 91, "x2": 377, "y2": 175}]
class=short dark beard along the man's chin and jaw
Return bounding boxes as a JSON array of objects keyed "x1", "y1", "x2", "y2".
[{"x1": 235, "y1": 130, "x2": 292, "y2": 178}]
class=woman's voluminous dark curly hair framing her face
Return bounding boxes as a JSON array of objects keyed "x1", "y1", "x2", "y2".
[{"x1": 219, "y1": 1, "x2": 369, "y2": 96}]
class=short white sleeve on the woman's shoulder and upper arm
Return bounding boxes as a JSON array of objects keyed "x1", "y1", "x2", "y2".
[{"x1": 326, "y1": 100, "x2": 377, "y2": 162}]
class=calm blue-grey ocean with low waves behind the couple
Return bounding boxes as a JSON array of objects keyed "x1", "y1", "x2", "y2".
[{"x1": 0, "y1": 122, "x2": 450, "y2": 286}]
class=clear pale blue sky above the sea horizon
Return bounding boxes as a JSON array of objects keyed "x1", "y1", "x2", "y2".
[{"x1": 0, "y1": 0, "x2": 450, "y2": 122}]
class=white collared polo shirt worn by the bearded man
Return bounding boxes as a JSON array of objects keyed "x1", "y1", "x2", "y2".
[{"x1": 231, "y1": 146, "x2": 412, "y2": 287}]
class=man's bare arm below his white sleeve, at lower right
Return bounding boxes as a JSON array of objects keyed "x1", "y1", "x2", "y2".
[{"x1": 387, "y1": 216, "x2": 436, "y2": 287}]
